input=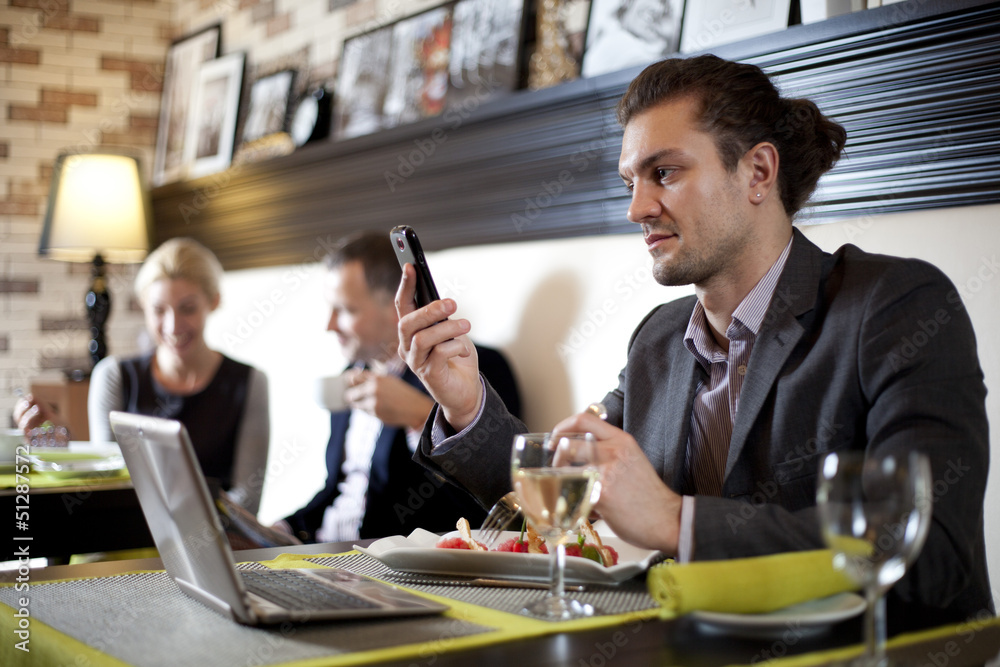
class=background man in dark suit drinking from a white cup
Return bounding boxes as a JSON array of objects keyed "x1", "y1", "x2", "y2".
[{"x1": 276, "y1": 233, "x2": 520, "y2": 542}]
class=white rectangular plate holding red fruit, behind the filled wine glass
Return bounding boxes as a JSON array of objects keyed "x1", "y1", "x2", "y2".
[{"x1": 354, "y1": 528, "x2": 660, "y2": 584}]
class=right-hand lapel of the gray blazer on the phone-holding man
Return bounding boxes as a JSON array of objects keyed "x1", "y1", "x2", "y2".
[{"x1": 726, "y1": 229, "x2": 823, "y2": 478}]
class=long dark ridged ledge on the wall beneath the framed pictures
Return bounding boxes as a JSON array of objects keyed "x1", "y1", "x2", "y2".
[{"x1": 152, "y1": 0, "x2": 1000, "y2": 269}]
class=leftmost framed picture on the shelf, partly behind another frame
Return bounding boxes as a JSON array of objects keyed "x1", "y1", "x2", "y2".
[{"x1": 152, "y1": 24, "x2": 222, "y2": 186}]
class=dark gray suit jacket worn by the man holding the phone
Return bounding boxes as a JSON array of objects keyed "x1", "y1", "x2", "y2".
[{"x1": 418, "y1": 230, "x2": 993, "y2": 630}]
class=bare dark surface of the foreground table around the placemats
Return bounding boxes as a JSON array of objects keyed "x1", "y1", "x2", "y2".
[{"x1": 0, "y1": 540, "x2": 1000, "y2": 667}]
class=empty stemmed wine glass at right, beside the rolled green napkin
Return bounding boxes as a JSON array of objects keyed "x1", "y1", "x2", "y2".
[{"x1": 816, "y1": 451, "x2": 932, "y2": 665}]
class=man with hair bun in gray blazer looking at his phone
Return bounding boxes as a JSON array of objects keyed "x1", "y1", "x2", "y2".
[{"x1": 396, "y1": 56, "x2": 994, "y2": 631}]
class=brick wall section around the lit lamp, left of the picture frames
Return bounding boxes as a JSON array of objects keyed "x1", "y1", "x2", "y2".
[{"x1": 0, "y1": 0, "x2": 174, "y2": 421}]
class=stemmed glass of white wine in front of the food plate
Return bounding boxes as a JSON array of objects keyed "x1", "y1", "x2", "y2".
[{"x1": 511, "y1": 433, "x2": 601, "y2": 620}]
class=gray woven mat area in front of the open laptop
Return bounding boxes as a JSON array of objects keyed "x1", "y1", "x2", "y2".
[{"x1": 0, "y1": 565, "x2": 493, "y2": 667}]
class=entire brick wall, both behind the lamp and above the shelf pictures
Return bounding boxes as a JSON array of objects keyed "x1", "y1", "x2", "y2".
[{"x1": 0, "y1": 0, "x2": 452, "y2": 420}]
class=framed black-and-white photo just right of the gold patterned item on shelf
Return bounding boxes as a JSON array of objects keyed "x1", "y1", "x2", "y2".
[{"x1": 582, "y1": 0, "x2": 684, "y2": 77}]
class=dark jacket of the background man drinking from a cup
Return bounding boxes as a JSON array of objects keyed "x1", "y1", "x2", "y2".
[{"x1": 286, "y1": 346, "x2": 521, "y2": 541}]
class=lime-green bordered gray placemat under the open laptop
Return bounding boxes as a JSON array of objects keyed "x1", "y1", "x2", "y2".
[{"x1": 0, "y1": 552, "x2": 658, "y2": 667}]
